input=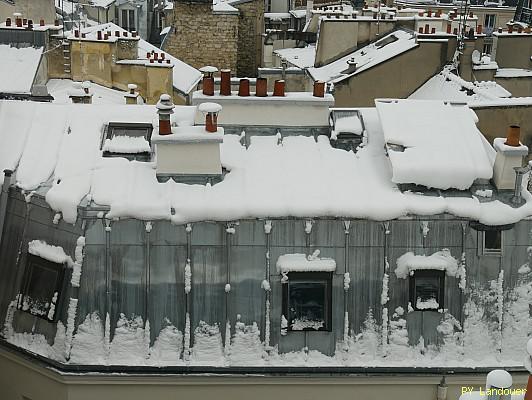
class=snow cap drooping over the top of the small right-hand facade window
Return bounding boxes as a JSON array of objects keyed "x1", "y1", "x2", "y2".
[{"x1": 395, "y1": 249, "x2": 458, "y2": 279}]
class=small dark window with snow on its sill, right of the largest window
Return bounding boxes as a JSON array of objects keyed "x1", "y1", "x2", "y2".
[{"x1": 410, "y1": 270, "x2": 445, "y2": 311}]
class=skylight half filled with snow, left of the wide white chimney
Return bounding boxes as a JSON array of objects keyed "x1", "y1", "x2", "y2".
[{"x1": 101, "y1": 122, "x2": 153, "y2": 161}]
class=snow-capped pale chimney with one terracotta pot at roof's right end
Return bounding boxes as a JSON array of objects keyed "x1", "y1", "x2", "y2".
[{"x1": 493, "y1": 125, "x2": 528, "y2": 190}]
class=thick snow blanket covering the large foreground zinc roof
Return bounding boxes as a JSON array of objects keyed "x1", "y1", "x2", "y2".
[{"x1": 0, "y1": 100, "x2": 532, "y2": 225}]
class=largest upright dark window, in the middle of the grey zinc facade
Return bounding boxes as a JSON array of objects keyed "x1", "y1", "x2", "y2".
[{"x1": 283, "y1": 272, "x2": 332, "y2": 331}]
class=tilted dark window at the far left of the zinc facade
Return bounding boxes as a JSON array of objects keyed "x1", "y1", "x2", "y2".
[{"x1": 17, "y1": 254, "x2": 65, "y2": 321}]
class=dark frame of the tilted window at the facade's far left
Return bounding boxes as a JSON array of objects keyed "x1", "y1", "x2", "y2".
[{"x1": 17, "y1": 253, "x2": 67, "y2": 322}]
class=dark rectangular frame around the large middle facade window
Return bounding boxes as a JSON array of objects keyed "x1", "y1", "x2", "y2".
[{"x1": 281, "y1": 271, "x2": 333, "y2": 332}]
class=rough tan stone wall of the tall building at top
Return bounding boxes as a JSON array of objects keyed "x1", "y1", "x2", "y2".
[{"x1": 164, "y1": 2, "x2": 239, "y2": 71}]
